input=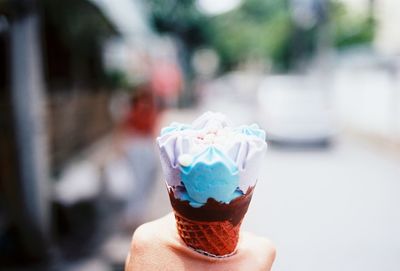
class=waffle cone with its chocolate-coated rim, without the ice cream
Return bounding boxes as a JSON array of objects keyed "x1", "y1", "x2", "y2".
[{"x1": 169, "y1": 188, "x2": 254, "y2": 257}]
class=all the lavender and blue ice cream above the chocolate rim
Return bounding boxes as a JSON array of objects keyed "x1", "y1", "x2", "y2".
[{"x1": 157, "y1": 112, "x2": 267, "y2": 208}]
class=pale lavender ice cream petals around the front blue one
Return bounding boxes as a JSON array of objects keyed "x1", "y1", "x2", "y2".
[{"x1": 157, "y1": 112, "x2": 267, "y2": 193}]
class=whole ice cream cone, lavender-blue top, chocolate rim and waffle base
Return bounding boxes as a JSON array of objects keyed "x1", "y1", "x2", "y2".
[{"x1": 157, "y1": 112, "x2": 267, "y2": 256}]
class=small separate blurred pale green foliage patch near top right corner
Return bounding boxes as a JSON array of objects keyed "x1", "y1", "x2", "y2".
[{"x1": 331, "y1": 0, "x2": 376, "y2": 48}]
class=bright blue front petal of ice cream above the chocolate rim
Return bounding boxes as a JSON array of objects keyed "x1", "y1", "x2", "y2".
[{"x1": 181, "y1": 146, "x2": 239, "y2": 204}]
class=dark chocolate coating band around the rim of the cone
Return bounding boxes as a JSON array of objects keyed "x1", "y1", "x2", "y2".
[{"x1": 168, "y1": 186, "x2": 254, "y2": 226}]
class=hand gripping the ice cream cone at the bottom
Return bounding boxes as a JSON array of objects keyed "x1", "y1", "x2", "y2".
[{"x1": 125, "y1": 213, "x2": 275, "y2": 271}]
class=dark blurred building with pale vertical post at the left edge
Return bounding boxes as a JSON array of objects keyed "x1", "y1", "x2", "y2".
[{"x1": 0, "y1": 1, "x2": 119, "y2": 263}]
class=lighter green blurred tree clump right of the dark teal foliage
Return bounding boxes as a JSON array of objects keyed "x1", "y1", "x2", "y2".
[{"x1": 209, "y1": 0, "x2": 291, "y2": 68}]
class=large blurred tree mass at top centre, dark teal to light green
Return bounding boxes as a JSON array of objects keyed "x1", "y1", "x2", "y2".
[{"x1": 148, "y1": 0, "x2": 290, "y2": 69}]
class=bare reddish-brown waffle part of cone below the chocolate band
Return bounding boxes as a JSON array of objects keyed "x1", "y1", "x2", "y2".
[{"x1": 175, "y1": 211, "x2": 243, "y2": 257}]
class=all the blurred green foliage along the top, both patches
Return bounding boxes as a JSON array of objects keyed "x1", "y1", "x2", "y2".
[{"x1": 148, "y1": 0, "x2": 375, "y2": 70}]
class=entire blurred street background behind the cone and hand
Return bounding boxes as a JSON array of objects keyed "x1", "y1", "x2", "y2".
[{"x1": 0, "y1": 0, "x2": 400, "y2": 271}]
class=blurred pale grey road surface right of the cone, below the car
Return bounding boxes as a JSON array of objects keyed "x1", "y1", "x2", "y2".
[{"x1": 244, "y1": 139, "x2": 400, "y2": 271}]
